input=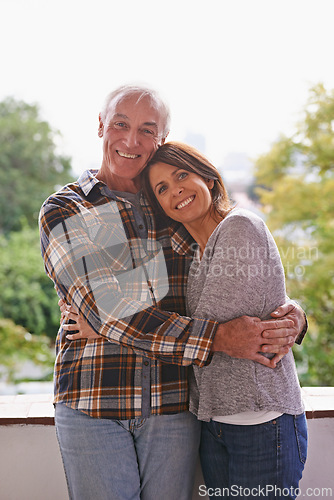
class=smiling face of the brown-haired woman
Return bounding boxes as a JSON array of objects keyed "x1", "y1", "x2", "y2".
[{"x1": 149, "y1": 163, "x2": 214, "y2": 224}]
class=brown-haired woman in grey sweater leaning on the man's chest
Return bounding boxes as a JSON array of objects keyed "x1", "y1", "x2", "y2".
[{"x1": 142, "y1": 143, "x2": 307, "y2": 498}]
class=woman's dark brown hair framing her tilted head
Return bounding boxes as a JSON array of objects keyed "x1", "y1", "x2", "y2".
[{"x1": 141, "y1": 142, "x2": 232, "y2": 217}]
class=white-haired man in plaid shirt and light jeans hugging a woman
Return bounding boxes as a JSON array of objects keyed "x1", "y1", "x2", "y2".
[{"x1": 40, "y1": 86, "x2": 305, "y2": 500}]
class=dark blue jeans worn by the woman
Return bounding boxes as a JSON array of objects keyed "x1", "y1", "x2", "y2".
[{"x1": 200, "y1": 414, "x2": 307, "y2": 499}]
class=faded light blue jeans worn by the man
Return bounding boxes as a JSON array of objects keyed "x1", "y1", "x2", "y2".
[{"x1": 55, "y1": 404, "x2": 201, "y2": 500}]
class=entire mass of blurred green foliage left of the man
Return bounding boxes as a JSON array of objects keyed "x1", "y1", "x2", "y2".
[{"x1": 0, "y1": 98, "x2": 73, "y2": 381}]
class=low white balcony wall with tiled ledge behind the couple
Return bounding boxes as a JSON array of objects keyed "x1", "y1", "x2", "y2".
[{"x1": 0, "y1": 388, "x2": 334, "y2": 500}]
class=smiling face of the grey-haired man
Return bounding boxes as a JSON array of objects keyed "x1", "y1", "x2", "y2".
[{"x1": 100, "y1": 95, "x2": 163, "y2": 189}]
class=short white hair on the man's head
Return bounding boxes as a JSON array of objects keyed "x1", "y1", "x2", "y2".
[{"x1": 100, "y1": 85, "x2": 170, "y2": 137}]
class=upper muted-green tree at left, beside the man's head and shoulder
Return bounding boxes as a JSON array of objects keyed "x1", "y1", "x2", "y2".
[{"x1": 0, "y1": 97, "x2": 72, "y2": 233}]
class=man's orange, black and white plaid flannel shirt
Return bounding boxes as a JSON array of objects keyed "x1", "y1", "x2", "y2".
[{"x1": 40, "y1": 171, "x2": 217, "y2": 419}]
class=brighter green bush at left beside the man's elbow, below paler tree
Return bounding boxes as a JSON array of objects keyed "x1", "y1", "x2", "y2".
[{"x1": 0, "y1": 225, "x2": 60, "y2": 339}]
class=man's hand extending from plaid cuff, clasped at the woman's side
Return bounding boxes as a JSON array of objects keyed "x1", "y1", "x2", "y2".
[{"x1": 212, "y1": 312, "x2": 295, "y2": 368}]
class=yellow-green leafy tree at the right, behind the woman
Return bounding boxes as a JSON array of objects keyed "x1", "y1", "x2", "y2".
[{"x1": 255, "y1": 84, "x2": 334, "y2": 385}]
